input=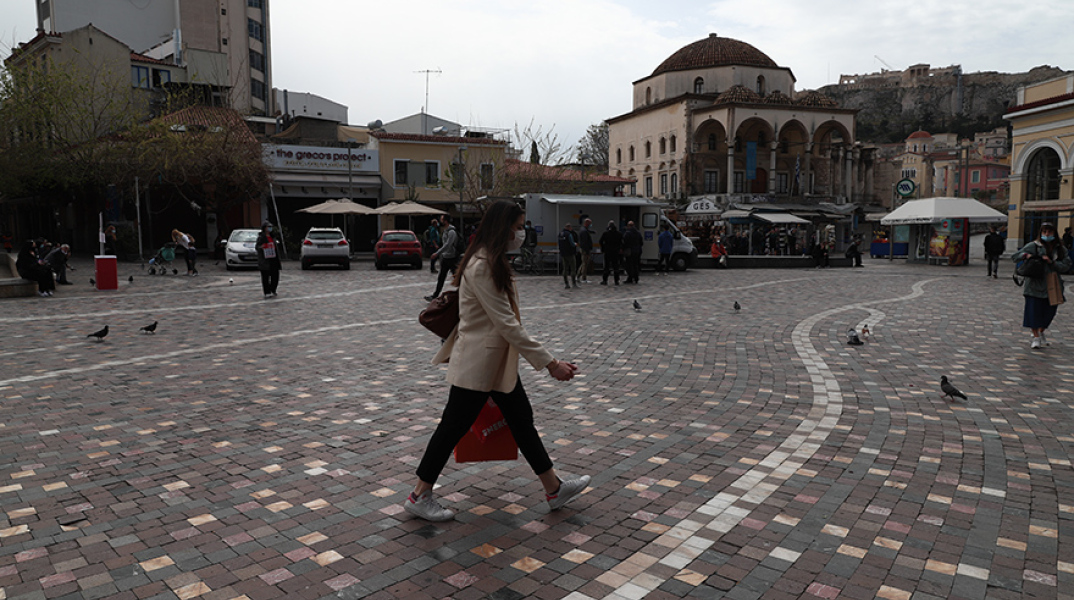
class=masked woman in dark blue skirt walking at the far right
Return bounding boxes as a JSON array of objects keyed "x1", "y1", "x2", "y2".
[{"x1": 1011, "y1": 223, "x2": 1071, "y2": 350}]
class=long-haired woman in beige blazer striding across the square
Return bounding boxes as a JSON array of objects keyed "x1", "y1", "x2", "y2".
[{"x1": 403, "y1": 201, "x2": 590, "y2": 521}]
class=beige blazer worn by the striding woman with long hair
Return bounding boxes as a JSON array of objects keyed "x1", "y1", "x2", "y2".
[{"x1": 433, "y1": 251, "x2": 553, "y2": 393}]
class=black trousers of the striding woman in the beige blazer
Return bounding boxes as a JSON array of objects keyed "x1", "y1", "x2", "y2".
[{"x1": 418, "y1": 379, "x2": 552, "y2": 483}]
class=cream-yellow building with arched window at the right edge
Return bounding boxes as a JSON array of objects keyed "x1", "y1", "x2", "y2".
[{"x1": 1004, "y1": 74, "x2": 1074, "y2": 251}]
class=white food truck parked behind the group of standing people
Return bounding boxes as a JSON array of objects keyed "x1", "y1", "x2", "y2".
[{"x1": 523, "y1": 193, "x2": 697, "y2": 270}]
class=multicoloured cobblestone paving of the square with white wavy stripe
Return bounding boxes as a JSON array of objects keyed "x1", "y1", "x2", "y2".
[{"x1": 0, "y1": 261, "x2": 1074, "y2": 600}]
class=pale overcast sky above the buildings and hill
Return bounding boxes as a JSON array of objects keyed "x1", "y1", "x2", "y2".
[{"x1": 0, "y1": 0, "x2": 1074, "y2": 154}]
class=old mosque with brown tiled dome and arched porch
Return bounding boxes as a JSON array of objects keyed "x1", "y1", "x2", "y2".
[{"x1": 607, "y1": 33, "x2": 874, "y2": 208}]
